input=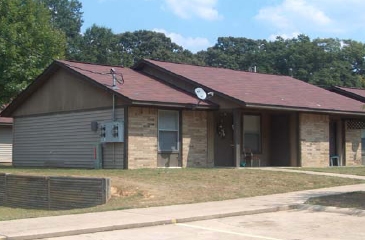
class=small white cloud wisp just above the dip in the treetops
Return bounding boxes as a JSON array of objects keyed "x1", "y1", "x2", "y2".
[{"x1": 152, "y1": 28, "x2": 211, "y2": 53}]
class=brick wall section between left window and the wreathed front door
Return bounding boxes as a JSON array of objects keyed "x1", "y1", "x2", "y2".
[{"x1": 182, "y1": 111, "x2": 209, "y2": 167}]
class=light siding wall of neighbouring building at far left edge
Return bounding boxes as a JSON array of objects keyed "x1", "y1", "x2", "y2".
[{"x1": 0, "y1": 126, "x2": 13, "y2": 163}]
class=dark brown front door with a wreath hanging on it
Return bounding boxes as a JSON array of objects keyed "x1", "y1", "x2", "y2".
[{"x1": 214, "y1": 111, "x2": 234, "y2": 167}]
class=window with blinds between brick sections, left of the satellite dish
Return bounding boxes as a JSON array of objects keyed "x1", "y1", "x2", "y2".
[{"x1": 158, "y1": 110, "x2": 179, "y2": 152}]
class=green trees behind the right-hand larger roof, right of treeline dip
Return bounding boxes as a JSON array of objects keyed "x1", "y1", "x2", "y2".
[{"x1": 197, "y1": 35, "x2": 365, "y2": 87}]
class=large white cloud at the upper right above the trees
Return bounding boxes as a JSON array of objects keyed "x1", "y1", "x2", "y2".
[{"x1": 255, "y1": 0, "x2": 365, "y2": 38}]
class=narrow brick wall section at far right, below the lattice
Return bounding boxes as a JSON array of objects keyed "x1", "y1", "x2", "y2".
[{"x1": 342, "y1": 127, "x2": 362, "y2": 166}]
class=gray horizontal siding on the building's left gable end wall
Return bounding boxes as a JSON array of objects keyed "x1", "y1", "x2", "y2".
[{"x1": 13, "y1": 108, "x2": 124, "y2": 168}]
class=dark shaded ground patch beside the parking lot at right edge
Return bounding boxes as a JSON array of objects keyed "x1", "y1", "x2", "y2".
[{"x1": 306, "y1": 191, "x2": 365, "y2": 210}]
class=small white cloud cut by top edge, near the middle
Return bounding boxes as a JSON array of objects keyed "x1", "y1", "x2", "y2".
[{"x1": 165, "y1": 0, "x2": 223, "y2": 21}]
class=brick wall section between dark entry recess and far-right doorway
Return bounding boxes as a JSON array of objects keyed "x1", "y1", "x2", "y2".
[{"x1": 299, "y1": 113, "x2": 329, "y2": 167}]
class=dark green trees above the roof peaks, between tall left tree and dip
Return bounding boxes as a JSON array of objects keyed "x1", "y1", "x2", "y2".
[{"x1": 73, "y1": 28, "x2": 199, "y2": 67}]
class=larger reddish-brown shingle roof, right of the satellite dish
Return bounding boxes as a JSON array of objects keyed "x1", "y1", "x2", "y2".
[{"x1": 135, "y1": 60, "x2": 365, "y2": 115}]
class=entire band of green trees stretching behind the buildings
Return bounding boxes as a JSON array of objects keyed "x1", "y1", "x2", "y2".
[{"x1": 0, "y1": 0, "x2": 365, "y2": 105}]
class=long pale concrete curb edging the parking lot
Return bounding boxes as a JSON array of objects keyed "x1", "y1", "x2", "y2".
[{"x1": 4, "y1": 205, "x2": 293, "y2": 240}]
